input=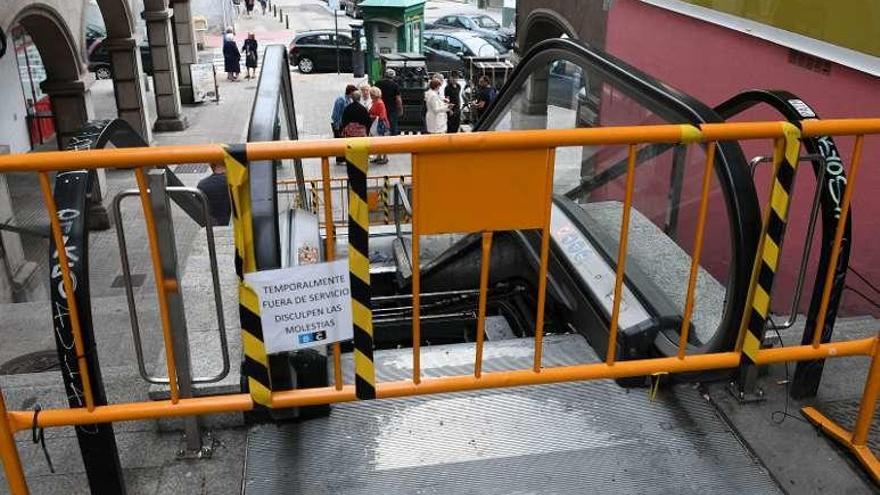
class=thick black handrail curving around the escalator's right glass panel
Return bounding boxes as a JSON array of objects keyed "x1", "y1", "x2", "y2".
[{"x1": 474, "y1": 38, "x2": 761, "y2": 352}]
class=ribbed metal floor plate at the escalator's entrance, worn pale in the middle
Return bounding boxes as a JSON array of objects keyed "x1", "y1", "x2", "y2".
[{"x1": 244, "y1": 335, "x2": 780, "y2": 495}]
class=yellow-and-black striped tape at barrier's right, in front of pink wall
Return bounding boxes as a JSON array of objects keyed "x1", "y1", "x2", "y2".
[{"x1": 740, "y1": 123, "x2": 801, "y2": 366}]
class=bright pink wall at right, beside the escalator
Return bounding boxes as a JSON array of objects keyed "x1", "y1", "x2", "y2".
[{"x1": 606, "y1": 0, "x2": 880, "y2": 314}]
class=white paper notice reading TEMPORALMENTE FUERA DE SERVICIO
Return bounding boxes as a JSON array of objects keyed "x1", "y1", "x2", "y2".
[{"x1": 244, "y1": 259, "x2": 353, "y2": 354}]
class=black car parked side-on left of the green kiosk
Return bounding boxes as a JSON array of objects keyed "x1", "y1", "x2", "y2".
[{"x1": 289, "y1": 30, "x2": 352, "y2": 74}]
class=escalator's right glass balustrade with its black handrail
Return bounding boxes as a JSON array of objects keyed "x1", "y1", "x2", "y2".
[{"x1": 388, "y1": 39, "x2": 760, "y2": 372}]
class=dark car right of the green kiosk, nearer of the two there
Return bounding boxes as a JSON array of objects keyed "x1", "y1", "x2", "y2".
[{"x1": 424, "y1": 29, "x2": 504, "y2": 73}]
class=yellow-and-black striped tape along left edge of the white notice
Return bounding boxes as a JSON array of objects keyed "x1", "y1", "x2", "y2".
[{"x1": 224, "y1": 144, "x2": 272, "y2": 407}]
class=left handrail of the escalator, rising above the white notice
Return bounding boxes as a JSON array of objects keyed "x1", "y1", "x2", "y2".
[{"x1": 247, "y1": 45, "x2": 308, "y2": 270}]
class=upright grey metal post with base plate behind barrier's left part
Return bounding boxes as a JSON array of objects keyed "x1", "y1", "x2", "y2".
[{"x1": 148, "y1": 169, "x2": 212, "y2": 458}]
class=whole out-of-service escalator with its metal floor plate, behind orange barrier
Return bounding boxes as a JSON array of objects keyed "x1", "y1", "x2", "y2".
[{"x1": 243, "y1": 40, "x2": 780, "y2": 495}]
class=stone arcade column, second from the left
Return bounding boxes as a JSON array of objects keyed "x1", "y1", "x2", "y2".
[{"x1": 104, "y1": 38, "x2": 153, "y2": 143}]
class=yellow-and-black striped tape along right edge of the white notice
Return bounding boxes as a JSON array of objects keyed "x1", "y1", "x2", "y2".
[{"x1": 345, "y1": 138, "x2": 376, "y2": 400}]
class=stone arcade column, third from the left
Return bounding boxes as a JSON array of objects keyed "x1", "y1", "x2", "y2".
[{"x1": 143, "y1": 0, "x2": 187, "y2": 132}]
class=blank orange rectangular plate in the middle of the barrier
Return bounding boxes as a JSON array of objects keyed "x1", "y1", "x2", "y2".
[{"x1": 414, "y1": 149, "x2": 552, "y2": 234}]
